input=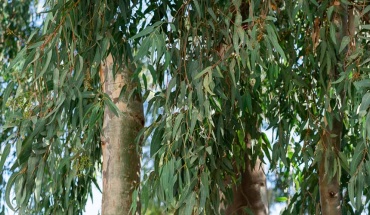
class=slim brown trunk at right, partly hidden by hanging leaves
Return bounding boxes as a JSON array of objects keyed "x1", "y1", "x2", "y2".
[{"x1": 319, "y1": 5, "x2": 354, "y2": 215}]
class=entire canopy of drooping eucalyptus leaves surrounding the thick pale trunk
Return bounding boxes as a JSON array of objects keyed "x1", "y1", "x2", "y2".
[{"x1": 0, "y1": 0, "x2": 370, "y2": 214}]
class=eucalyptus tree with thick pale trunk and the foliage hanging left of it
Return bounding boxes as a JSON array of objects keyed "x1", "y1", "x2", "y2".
[{"x1": 2, "y1": 0, "x2": 143, "y2": 214}]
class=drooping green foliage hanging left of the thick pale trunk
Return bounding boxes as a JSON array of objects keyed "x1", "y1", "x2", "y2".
[{"x1": 3, "y1": 0, "x2": 142, "y2": 214}]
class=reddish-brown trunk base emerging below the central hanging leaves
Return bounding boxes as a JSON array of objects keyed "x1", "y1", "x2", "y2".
[{"x1": 226, "y1": 134, "x2": 269, "y2": 215}]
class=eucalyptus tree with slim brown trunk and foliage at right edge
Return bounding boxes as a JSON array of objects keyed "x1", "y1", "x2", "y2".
[{"x1": 267, "y1": 1, "x2": 370, "y2": 214}]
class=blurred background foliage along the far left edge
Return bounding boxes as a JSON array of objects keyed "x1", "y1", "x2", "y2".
[{"x1": 0, "y1": 1, "x2": 38, "y2": 214}]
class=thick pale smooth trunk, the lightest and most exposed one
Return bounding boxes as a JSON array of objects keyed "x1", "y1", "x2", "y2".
[{"x1": 101, "y1": 56, "x2": 144, "y2": 215}]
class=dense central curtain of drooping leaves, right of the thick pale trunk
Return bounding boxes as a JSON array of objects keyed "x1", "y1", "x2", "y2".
[{"x1": 136, "y1": 1, "x2": 272, "y2": 214}]
